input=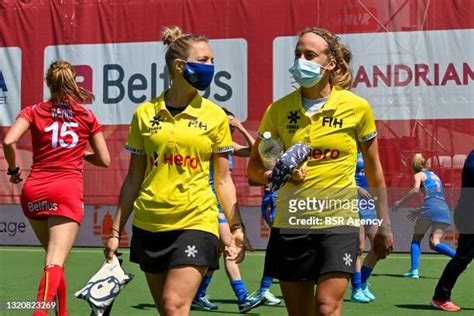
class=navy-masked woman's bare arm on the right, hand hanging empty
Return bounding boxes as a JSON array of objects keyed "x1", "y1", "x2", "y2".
[{"x1": 212, "y1": 153, "x2": 245, "y2": 261}]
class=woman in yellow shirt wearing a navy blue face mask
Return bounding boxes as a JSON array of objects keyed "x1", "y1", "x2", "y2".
[{"x1": 106, "y1": 27, "x2": 244, "y2": 315}]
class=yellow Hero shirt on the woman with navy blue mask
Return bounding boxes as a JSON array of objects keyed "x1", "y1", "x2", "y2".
[{"x1": 125, "y1": 92, "x2": 232, "y2": 236}]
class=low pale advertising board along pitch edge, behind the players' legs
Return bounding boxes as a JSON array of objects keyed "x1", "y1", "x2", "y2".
[{"x1": 0, "y1": 205, "x2": 457, "y2": 252}]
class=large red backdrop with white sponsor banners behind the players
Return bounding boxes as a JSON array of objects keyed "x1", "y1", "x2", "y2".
[{"x1": 0, "y1": 0, "x2": 474, "y2": 209}]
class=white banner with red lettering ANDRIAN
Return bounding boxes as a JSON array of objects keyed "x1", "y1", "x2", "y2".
[{"x1": 273, "y1": 30, "x2": 474, "y2": 120}]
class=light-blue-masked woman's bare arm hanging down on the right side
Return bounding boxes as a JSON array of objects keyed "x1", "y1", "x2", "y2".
[{"x1": 359, "y1": 138, "x2": 393, "y2": 259}]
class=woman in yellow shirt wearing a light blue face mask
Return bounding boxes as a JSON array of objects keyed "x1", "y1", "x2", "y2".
[{"x1": 248, "y1": 27, "x2": 393, "y2": 316}]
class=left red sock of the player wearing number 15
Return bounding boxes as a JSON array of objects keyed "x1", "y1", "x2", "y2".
[{"x1": 33, "y1": 264, "x2": 64, "y2": 316}]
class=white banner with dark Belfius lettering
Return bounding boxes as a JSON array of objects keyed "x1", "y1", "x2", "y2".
[{"x1": 44, "y1": 39, "x2": 248, "y2": 125}]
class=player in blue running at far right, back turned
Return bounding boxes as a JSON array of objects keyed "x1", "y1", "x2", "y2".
[{"x1": 393, "y1": 154, "x2": 456, "y2": 279}]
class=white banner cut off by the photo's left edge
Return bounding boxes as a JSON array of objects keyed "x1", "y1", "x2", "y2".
[{"x1": 0, "y1": 47, "x2": 21, "y2": 126}]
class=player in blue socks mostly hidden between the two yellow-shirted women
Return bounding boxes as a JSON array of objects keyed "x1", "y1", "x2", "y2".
[{"x1": 191, "y1": 108, "x2": 265, "y2": 313}]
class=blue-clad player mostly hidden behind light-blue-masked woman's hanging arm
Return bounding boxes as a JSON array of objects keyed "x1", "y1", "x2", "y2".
[{"x1": 351, "y1": 152, "x2": 377, "y2": 303}]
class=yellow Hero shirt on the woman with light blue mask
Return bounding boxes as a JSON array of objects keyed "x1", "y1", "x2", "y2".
[{"x1": 259, "y1": 87, "x2": 377, "y2": 229}]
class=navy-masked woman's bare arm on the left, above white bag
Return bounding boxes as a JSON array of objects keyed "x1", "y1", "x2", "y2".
[{"x1": 105, "y1": 154, "x2": 146, "y2": 259}]
